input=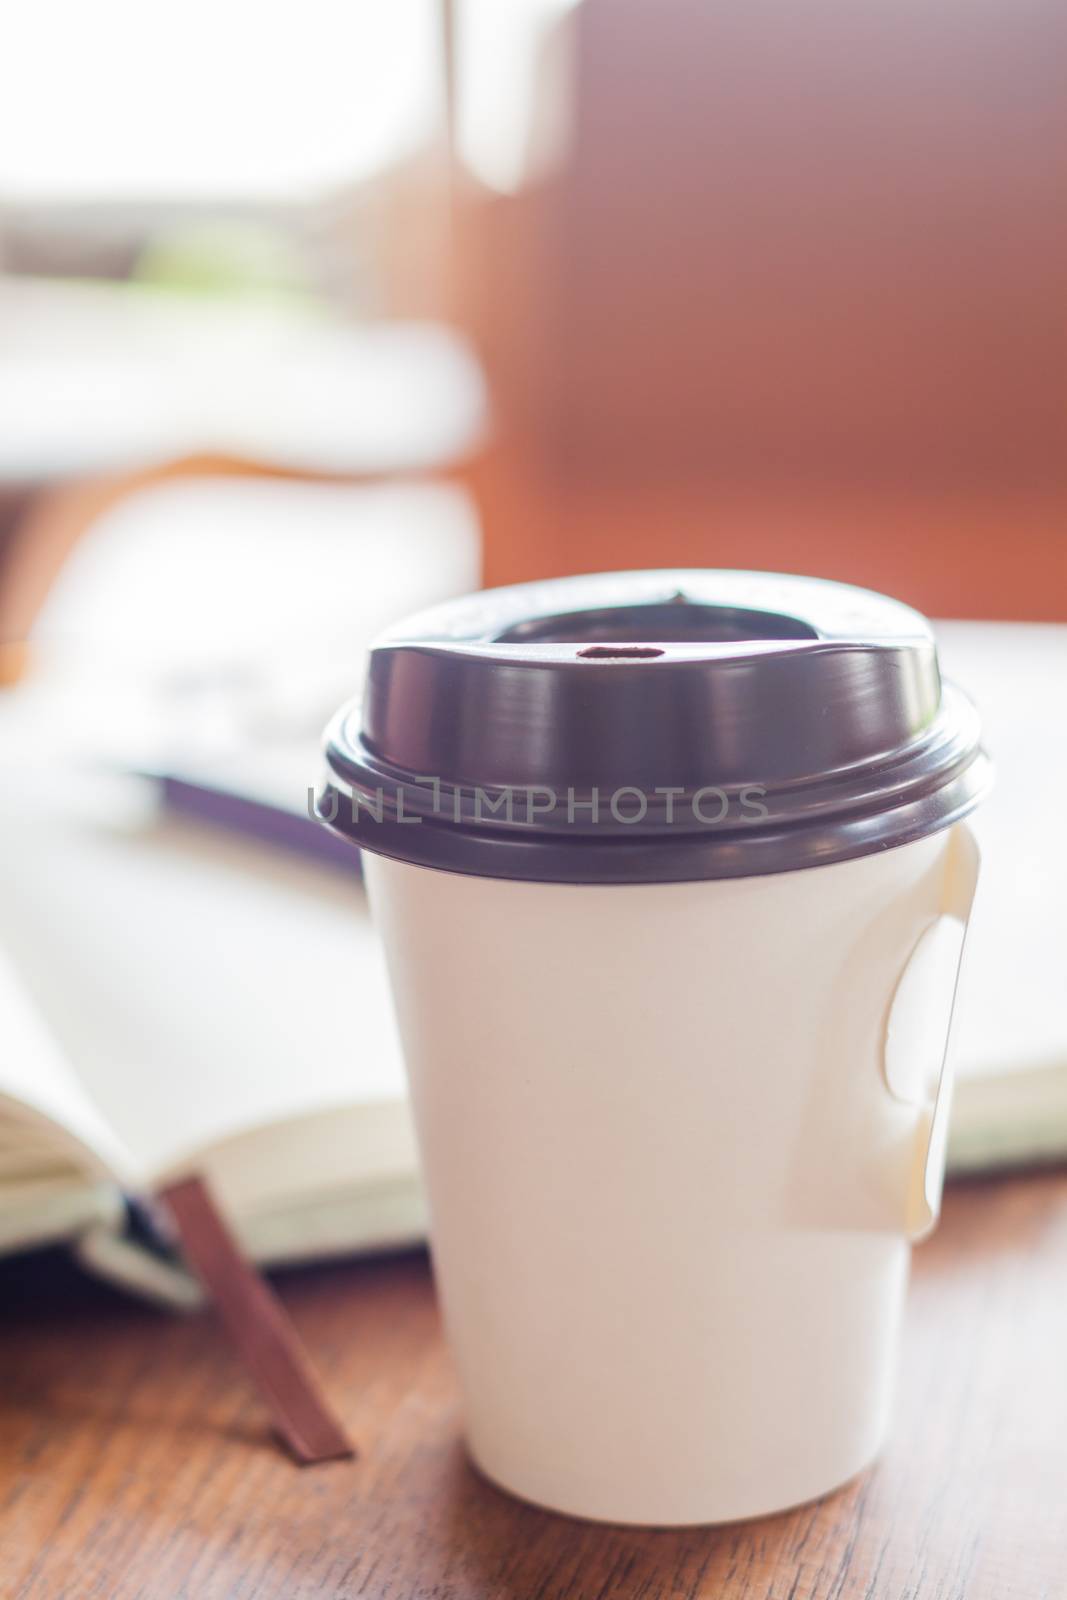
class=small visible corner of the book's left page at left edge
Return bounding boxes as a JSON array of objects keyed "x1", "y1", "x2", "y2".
[{"x1": 0, "y1": 949, "x2": 136, "y2": 1190}]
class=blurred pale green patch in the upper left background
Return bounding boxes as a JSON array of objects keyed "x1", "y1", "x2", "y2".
[{"x1": 133, "y1": 221, "x2": 314, "y2": 299}]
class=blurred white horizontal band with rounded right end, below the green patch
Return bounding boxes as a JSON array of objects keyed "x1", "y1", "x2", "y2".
[{"x1": 0, "y1": 278, "x2": 486, "y2": 478}]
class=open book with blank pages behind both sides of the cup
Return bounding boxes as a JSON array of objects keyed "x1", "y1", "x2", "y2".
[{"x1": 0, "y1": 624, "x2": 1067, "y2": 1302}]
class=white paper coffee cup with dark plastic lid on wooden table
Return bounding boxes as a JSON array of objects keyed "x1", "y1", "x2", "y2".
[{"x1": 323, "y1": 574, "x2": 985, "y2": 1525}]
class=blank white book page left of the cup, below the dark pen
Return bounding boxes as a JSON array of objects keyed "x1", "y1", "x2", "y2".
[{"x1": 0, "y1": 800, "x2": 405, "y2": 1184}]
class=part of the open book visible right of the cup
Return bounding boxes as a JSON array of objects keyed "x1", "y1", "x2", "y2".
[{"x1": 936, "y1": 622, "x2": 1067, "y2": 1173}]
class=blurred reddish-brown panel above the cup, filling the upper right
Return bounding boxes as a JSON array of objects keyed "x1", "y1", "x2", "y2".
[{"x1": 459, "y1": 0, "x2": 1067, "y2": 618}]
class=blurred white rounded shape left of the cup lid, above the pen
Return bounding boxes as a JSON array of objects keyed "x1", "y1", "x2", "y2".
[{"x1": 32, "y1": 477, "x2": 480, "y2": 771}]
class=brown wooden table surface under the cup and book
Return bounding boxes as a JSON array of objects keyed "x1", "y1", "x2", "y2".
[{"x1": 0, "y1": 1173, "x2": 1067, "y2": 1600}]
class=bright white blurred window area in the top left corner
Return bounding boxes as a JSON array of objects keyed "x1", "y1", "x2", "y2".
[{"x1": 0, "y1": 0, "x2": 440, "y2": 202}]
